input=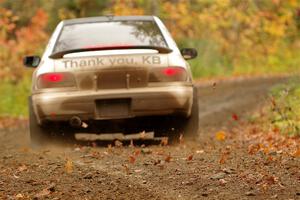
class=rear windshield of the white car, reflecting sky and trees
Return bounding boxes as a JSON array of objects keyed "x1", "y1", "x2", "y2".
[{"x1": 53, "y1": 21, "x2": 167, "y2": 53}]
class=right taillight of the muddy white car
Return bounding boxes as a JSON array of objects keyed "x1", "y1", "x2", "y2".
[{"x1": 149, "y1": 66, "x2": 188, "y2": 82}]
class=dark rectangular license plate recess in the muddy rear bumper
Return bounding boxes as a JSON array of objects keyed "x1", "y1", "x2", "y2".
[{"x1": 96, "y1": 99, "x2": 131, "y2": 118}]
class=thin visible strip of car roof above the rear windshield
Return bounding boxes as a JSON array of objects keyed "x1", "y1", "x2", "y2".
[{"x1": 63, "y1": 15, "x2": 154, "y2": 25}]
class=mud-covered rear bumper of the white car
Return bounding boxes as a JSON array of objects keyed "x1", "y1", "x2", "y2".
[{"x1": 32, "y1": 85, "x2": 193, "y2": 122}]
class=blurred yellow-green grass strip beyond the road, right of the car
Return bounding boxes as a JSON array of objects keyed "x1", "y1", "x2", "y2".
[{"x1": 177, "y1": 39, "x2": 300, "y2": 78}]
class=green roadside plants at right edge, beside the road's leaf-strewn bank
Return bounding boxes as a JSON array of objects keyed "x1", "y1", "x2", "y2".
[{"x1": 269, "y1": 77, "x2": 300, "y2": 136}]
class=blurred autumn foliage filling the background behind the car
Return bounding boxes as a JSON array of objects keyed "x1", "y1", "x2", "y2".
[{"x1": 0, "y1": 0, "x2": 300, "y2": 116}]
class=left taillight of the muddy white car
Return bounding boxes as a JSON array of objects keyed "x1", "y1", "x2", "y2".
[{"x1": 37, "y1": 72, "x2": 76, "y2": 89}]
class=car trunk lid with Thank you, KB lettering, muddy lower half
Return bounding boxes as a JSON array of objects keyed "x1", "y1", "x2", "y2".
[{"x1": 55, "y1": 50, "x2": 168, "y2": 90}]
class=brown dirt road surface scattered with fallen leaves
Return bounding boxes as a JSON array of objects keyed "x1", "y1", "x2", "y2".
[{"x1": 0, "y1": 78, "x2": 300, "y2": 200}]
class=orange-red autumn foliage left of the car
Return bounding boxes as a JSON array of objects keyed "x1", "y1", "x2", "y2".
[{"x1": 0, "y1": 8, "x2": 48, "y2": 81}]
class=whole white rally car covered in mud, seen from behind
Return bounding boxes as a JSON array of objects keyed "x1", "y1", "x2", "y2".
[{"x1": 24, "y1": 16, "x2": 199, "y2": 144}]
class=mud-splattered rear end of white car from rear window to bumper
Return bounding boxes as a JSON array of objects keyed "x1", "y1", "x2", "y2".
[{"x1": 32, "y1": 17, "x2": 192, "y2": 125}]
